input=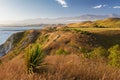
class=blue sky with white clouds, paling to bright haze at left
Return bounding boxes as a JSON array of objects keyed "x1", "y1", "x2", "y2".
[{"x1": 0, "y1": 0, "x2": 120, "y2": 23}]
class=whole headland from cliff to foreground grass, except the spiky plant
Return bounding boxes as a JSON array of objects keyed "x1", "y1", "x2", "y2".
[{"x1": 0, "y1": 26, "x2": 120, "y2": 80}]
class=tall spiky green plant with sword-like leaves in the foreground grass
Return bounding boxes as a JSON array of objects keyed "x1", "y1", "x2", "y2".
[{"x1": 25, "y1": 44, "x2": 45, "y2": 73}]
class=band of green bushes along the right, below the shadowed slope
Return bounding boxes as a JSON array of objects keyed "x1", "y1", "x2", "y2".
[{"x1": 83, "y1": 45, "x2": 120, "y2": 68}]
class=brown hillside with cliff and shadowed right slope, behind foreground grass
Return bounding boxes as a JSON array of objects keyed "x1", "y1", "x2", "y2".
[{"x1": 0, "y1": 27, "x2": 120, "y2": 61}]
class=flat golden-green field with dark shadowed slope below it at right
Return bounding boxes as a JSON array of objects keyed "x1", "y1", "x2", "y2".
[{"x1": 71, "y1": 28, "x2": 120, "y2": 48}]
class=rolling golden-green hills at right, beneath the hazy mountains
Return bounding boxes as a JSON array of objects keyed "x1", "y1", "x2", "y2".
[{"x1": 67, "y1": 18, "x2": 120, "y2": 28}]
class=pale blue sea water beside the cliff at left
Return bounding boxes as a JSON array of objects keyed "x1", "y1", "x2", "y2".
[{"x1": 0, "y1": 26, "x2": 42, "y2": 44}]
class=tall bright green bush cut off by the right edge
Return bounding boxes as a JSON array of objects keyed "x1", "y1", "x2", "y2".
[{"x1": 108, "y1": 45, "x2": 120, "y2": 68}]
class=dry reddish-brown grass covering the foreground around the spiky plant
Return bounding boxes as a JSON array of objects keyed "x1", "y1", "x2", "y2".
[{"x1": 0, "y1": 55, "x2": 120, "y2": 80}]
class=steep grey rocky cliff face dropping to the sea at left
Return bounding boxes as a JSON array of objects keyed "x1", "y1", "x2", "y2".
[{"x1": 0, "y1": 31, "x2": 37, "y2": 56}]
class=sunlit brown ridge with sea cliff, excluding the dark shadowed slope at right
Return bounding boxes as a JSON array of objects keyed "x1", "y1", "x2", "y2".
[{"x1": 0, "y1": 28, "x2": 98, "y2": 61}]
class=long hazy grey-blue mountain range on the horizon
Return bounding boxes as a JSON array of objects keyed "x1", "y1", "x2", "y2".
[{"x1": 2, "y1": 14, "x2": 120, "y2": 26}]
